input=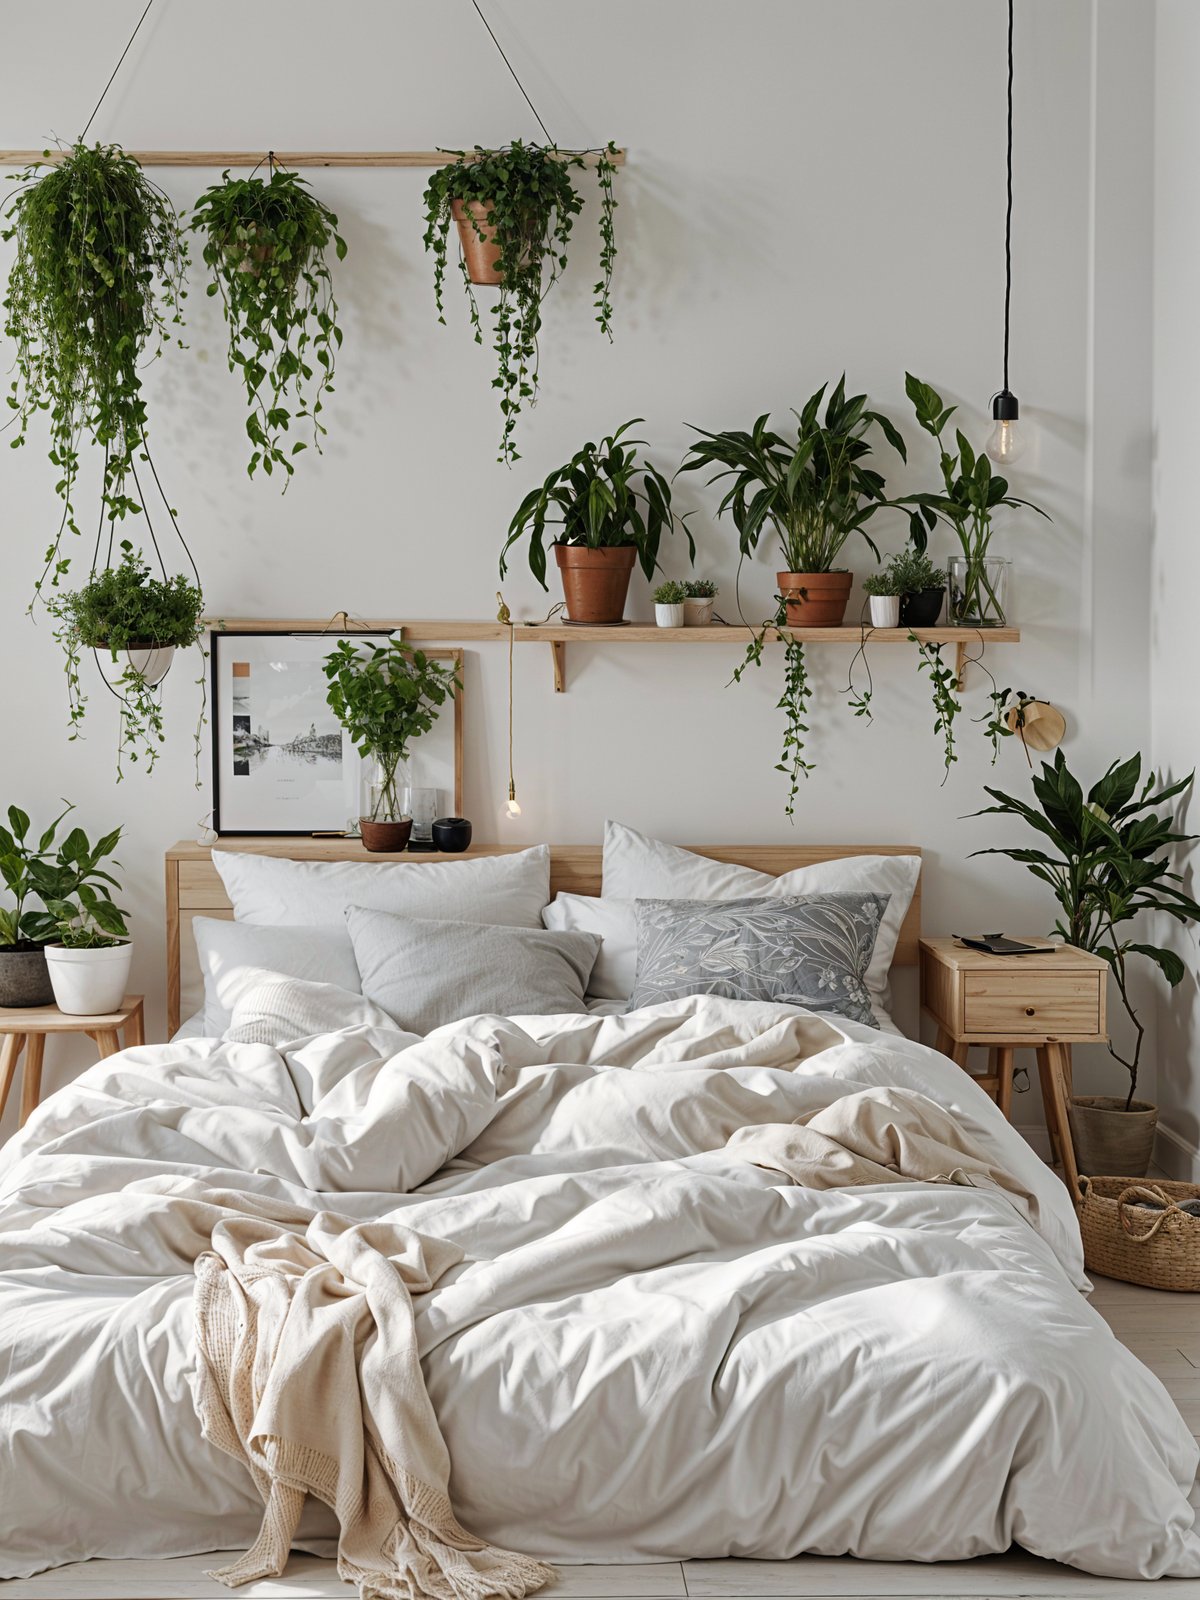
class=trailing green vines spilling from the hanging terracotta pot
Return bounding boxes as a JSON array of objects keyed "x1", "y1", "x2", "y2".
[{"x1": 424, "y1": 139, "x2": 616, "y2": 466}]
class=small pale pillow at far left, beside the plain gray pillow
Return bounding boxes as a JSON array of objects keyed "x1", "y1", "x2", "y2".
[{"x1": 192, "y1": 917, "x2": 363, "y2": 1038}]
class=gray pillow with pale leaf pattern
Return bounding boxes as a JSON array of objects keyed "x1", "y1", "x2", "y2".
[{"x1": 630, "y1": 894, "x2": 890, "y2": 1027}]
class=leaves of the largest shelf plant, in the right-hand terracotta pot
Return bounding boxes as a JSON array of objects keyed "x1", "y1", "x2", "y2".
[{"x1": 680, "y1": 373, "x2": 907, "y2": 573}]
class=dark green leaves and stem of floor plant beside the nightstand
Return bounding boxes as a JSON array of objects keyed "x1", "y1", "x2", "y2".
[{"x1": 974, "y1": 750, "x2": 1200, "y2": 1109}]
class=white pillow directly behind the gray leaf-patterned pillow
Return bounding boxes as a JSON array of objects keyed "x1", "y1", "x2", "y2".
[{"x1": 600, "y1": 822, "x2": 922, "y2": 1032}]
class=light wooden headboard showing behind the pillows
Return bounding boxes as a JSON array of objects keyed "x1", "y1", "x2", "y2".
[{"x1": 166, "y1": 837, "x2": 922, "y2": 1034}]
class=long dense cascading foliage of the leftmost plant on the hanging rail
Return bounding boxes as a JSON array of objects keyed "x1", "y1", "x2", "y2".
[{"x1": 0, "y1": 144, "x2": 187, "y2": 598}]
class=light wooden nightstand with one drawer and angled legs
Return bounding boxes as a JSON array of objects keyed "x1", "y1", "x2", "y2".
[{"x1": 920, "y1": 938, "x2": 1109, "y2": 1195}]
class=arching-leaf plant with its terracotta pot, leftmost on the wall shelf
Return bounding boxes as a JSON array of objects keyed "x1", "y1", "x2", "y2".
[{"x1": 499, "y1": 418, "x2": 696, "y2": 626}]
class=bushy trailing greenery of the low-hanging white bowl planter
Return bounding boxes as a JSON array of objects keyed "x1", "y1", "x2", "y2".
[{"x1": 46, "y1": 539, "x2": 208, "y2": 787}]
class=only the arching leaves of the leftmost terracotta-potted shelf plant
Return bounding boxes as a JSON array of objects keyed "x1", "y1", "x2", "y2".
[{"x1": 499, "y1": 416, "x2": 696, "y2": 589}]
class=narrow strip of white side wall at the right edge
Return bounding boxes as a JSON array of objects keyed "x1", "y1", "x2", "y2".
[{"x1": 1150, "y1": 0, "x2": 1200, "y2": 1179}]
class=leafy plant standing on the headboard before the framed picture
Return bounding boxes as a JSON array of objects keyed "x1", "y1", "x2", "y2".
[{"x1": 323, "y1": 638, "x2": 458, "y2": 851}]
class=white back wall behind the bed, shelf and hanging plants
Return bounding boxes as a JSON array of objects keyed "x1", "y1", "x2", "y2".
[{"x1": 0, "y1": 0, "x2": 1150, "y2": 1131}]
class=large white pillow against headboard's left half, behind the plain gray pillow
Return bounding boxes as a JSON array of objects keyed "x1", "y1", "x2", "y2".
[{"x1": 213, "y1": 845, "x2": 550, "y2": 934}]
